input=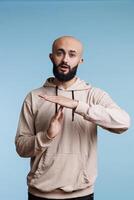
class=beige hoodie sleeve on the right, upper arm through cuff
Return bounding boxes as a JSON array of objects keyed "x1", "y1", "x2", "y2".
[{"x1": 75, "y1": 89, "x2": 130, "y2": 133}]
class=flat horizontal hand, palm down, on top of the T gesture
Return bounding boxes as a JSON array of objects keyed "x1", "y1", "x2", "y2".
[{"x1": 39, "y1": 95, "x2": 78, "y2": 109}]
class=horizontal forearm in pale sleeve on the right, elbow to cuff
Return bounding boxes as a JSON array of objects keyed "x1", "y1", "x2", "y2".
[{"x1": 75, "y1": 102, "x2": 130, "y2": 133}]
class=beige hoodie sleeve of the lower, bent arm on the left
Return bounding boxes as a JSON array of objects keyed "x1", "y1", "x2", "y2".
[{"x1": 15, "y1": 97, "x2": 52, "y2": 157}]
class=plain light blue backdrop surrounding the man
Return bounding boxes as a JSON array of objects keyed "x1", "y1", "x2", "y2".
[{"x1": 0, "y1": 0, "x2": 134, "y2": 200}]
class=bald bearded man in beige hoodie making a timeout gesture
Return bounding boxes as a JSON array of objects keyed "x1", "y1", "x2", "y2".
[{"x1": 15, "y1": 36, "x2": 130, "y2": 200}]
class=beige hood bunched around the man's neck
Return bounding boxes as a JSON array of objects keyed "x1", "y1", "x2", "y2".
[{"x1": 43, "y1": 77, "x2": 91, "y2": 91}]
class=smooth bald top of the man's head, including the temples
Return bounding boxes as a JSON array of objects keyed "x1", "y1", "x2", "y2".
[{"x1": 52, "y1": 36, "x2": 83, "y2": 56}]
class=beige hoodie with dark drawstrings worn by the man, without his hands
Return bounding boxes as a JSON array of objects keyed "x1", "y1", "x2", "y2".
[{"x1": 15, "y1": 78, "x2": 130, "y2": 199}]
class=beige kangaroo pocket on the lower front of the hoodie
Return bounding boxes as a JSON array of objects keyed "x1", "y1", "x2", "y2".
[{"x1": 28, "y1": 154, "x2": 92, "y2": 192}]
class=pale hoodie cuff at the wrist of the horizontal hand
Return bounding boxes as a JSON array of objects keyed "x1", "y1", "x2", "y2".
[{"x1": 75, "y1": 101, "x2": 89, "y2": 117}]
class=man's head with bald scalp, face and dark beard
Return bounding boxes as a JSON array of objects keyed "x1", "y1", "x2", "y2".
[{"x1": 50, "y1": 37, "x2": 82, "y2": 81}]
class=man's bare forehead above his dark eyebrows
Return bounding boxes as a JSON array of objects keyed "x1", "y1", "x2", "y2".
[{"x1": 53, "y1": 38, "x2": 82, "y2": 53}]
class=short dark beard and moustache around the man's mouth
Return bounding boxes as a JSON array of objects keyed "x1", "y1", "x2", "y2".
[{"x1": 53, "y1": 63, "x2": 78, "y2": 82}]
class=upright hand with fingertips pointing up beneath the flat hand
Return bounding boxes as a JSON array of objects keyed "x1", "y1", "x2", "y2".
[{"x1": 47, "y1": 106, "x2": 63, "y2": 139}]
